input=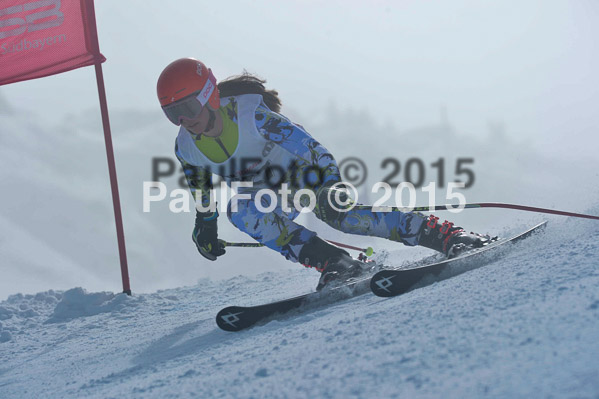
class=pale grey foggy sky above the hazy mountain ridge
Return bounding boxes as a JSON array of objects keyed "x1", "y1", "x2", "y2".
[{"x1": 0, "y1": 0, "x2": 599, "y2": 157}]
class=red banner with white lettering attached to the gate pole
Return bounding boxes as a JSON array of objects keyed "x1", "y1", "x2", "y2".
[{"x1": 0, "y1": 0, "x2": 106, "y2": 85}]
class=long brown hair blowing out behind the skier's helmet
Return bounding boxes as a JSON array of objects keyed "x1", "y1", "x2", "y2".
[{"x1": 217, "y1": 71, "x2": 281, "y2": 113}]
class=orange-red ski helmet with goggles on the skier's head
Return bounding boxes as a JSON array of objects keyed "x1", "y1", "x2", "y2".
[{"x1": 156, "y1": 58, "x2": 220, "y2": 125}]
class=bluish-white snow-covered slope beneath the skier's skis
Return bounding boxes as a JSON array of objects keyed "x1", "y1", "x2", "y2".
[{"x1": 0, "y1": 219, "x2": 599, "y2": 399}]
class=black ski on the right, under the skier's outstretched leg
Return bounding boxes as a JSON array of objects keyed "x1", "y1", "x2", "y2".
[{"x1": 370, "y1": 222, "x2": 547, "y2": 297}]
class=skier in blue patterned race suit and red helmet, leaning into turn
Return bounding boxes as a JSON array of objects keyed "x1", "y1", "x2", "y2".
[{"x1": 157, "y1": 58, "x2": 491, "y2": 289}]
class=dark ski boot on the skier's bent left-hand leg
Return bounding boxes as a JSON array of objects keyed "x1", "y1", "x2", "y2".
[{"x1": 299, "y1": 236, "x2": 370, "y2": 291}]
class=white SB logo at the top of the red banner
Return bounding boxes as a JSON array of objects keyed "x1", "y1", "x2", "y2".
[{"x1": 0, "y1": 0, "x2": 64, "y2": 39}]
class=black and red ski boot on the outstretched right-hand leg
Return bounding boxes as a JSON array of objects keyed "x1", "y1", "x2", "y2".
[{"x1": 418, "y1": 215, "x2": 497, "y2": 259}]
